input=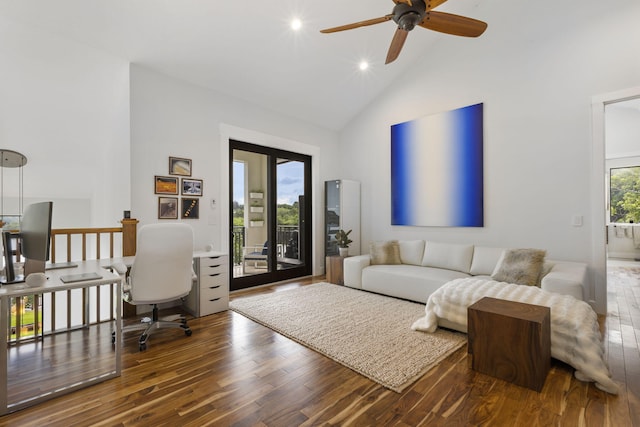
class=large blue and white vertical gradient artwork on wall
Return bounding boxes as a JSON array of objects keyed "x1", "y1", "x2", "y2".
[{"x1": 391, "y1": 103, "x2": 484, "y2": 227}]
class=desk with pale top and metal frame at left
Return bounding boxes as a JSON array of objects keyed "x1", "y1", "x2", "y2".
[{"x1": 0, "y1": 260, "x2": 122, "y2": 415}]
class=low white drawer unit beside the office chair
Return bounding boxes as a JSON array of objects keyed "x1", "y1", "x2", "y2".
[{"x1": 184, "y1": 251, "x2": 229, "y2": 317}]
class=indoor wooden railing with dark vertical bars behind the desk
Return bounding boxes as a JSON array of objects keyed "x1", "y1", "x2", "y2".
[{"x1": 8, "y1": 219, "x2": 137, "y2": 342}]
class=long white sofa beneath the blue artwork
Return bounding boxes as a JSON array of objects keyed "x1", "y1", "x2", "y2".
[{"x1": 344, "y1": 240, "x2": 587, "y2": 303}]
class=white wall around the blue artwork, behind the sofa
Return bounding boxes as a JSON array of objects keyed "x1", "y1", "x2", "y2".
[{"x1": 340, "y1": 0, "x2": 640, "y2": 312}]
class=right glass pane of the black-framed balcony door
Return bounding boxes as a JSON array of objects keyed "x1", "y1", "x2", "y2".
[{"x1": 276, "y1": 158, "x2": 305, "y2": 270}]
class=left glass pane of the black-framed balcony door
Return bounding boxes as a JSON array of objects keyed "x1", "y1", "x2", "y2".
[{"x1": 232, "y1": 150, "x2": 270, "y2": 277}]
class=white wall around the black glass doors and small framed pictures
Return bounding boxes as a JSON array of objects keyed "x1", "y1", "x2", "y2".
[{"x1": 131, "y1": 65, "x2": 338, "y2": 274}]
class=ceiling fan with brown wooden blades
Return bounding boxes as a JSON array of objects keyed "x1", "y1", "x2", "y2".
[{"x1": 320, "y1": 0, "x2": 487, "y2": 64}]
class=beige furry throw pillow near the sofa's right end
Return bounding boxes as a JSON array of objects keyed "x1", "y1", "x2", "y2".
[{"x1": 491, "y1": 249, "x2": 546, "y2": 286}]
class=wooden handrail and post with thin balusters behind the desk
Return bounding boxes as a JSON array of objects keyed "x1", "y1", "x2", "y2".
[{"x1": 9, "y1": 219, "x2": 138, "y2": 341}]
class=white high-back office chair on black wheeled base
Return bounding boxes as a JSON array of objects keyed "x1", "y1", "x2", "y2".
[{"x1": 112, "y1": 223, "x2": 195, "y2": 351}]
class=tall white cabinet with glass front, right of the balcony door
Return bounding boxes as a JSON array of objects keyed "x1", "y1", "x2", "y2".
[{"x1": 324, "y1": 179, "x2": 360, "y2": 256}]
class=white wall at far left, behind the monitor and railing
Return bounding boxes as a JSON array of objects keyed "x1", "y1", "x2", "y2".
[{"x1": 0, "y1": 16, "x2": 130, "y2": 227}]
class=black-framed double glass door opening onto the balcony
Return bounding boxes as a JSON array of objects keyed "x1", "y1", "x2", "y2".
[{"x1": 229, "y1": 140, "x2": 312, "y2": 290}]
